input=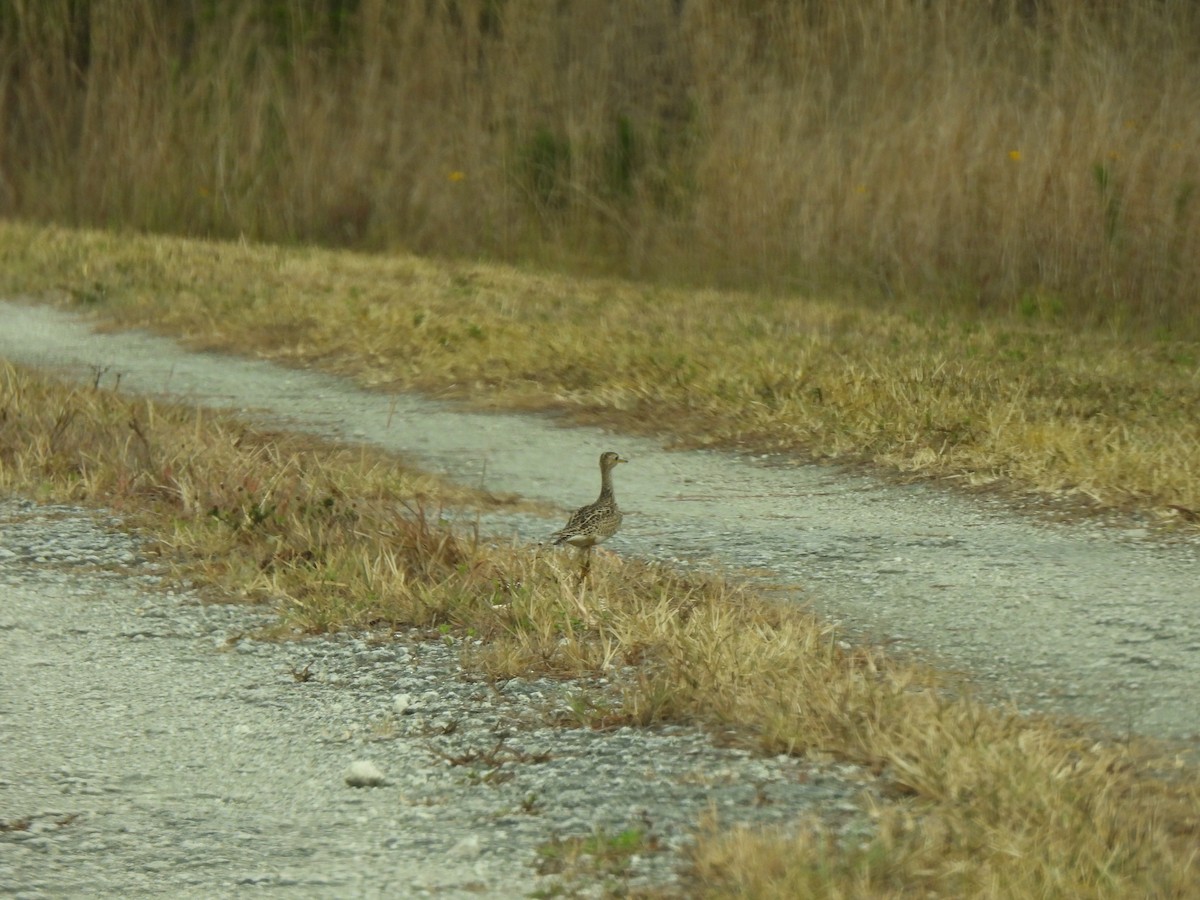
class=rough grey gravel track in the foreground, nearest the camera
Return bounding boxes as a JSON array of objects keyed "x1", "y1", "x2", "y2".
[{"x1": 0, "y1": 499, "x2": 874, "y2": 898}]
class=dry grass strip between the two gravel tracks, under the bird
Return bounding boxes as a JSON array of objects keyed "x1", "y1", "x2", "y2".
[{"x1": 0, "y1": 366, "x2": 1200, "y2": 898}]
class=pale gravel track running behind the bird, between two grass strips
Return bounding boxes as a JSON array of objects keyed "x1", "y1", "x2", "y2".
[{"x1": 0, "y1": 302, "x2": 1200, "y2": 742}]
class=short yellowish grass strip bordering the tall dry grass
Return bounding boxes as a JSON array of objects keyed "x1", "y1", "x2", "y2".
[{"x1": 0, "y1": 223, "x2": 1200, "y2": 524}]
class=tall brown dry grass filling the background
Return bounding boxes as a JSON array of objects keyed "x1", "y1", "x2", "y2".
[{"x1": 0, "y1": 0, "x2": 1200, "y2": 325}]
